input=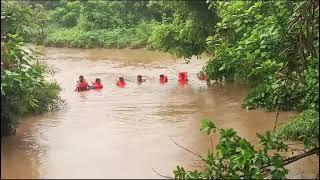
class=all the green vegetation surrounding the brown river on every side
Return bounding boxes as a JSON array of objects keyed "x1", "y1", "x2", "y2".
[{"x1": 1, "y1": 0, "x2": 319, "y2": 179}]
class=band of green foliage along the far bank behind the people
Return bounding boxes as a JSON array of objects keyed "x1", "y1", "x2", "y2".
[{"x1": 14, "y1": 0, "x2": 217, "y2": 55}]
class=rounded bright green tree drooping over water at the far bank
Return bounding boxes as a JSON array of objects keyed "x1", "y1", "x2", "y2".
[{"x1": 149, "y1": 1, "x2": 217, "y2": 58}]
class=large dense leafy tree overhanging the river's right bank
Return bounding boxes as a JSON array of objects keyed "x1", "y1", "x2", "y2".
[{"x1": 206, "y1": 1, "x2": 319, "y2": 110}]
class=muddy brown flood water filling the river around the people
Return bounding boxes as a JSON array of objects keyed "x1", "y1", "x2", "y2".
[{"x1": 1, "y1": 48, "x2": 319, "y2": 179}]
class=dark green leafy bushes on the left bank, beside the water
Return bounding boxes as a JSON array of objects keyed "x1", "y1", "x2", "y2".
[{"x1": 1, "y1": 1, "x2": 62, "y2": 137}]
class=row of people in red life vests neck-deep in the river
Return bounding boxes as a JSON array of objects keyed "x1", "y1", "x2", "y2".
[{"x1": 76, "y1": 72, "x2": 207, "y2": 91}]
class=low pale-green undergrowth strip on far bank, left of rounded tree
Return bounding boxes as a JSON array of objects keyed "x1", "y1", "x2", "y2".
[{"x1": 44, "y1": 24, "x2": 151, "y2": 49}]
